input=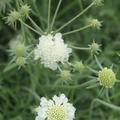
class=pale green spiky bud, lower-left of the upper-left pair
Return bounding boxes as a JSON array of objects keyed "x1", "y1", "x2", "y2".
[{"x1": 7, "y1": 10, "x2": 20, "y2": 24}]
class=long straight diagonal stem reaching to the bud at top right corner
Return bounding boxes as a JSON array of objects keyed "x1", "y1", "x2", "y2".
[{"x1": 56, "y1": 2, "x2": 94, "y2": 32}]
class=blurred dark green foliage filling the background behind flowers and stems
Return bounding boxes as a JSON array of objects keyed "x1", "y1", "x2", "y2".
[{"x1": 0, "y1": 0, "x2": 120, "y2": 120}]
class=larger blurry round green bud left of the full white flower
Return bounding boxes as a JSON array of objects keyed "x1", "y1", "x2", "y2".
[{"x1": 14, "y1": 44, "x2": 26, "y2": 57}]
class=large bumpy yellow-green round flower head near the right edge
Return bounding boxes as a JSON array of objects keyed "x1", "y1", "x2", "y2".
[{"x1": 98, "y1": 67, "x2": 116, "y2": 88}]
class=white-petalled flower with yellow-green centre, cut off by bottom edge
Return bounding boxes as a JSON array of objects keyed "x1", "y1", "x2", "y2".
[{"x1": 35, "y1": 94, "x2": 76, "y2": 120}]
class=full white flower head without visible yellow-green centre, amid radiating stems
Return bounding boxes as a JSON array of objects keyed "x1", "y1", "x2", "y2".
[{"x1": 34, "y1": 33, "x2": 72, "y2": 70}]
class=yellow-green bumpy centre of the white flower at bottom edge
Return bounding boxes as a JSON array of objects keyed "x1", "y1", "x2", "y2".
[{"x1": 48, "y1": 105, "x2": 66, "y2": 120}]
